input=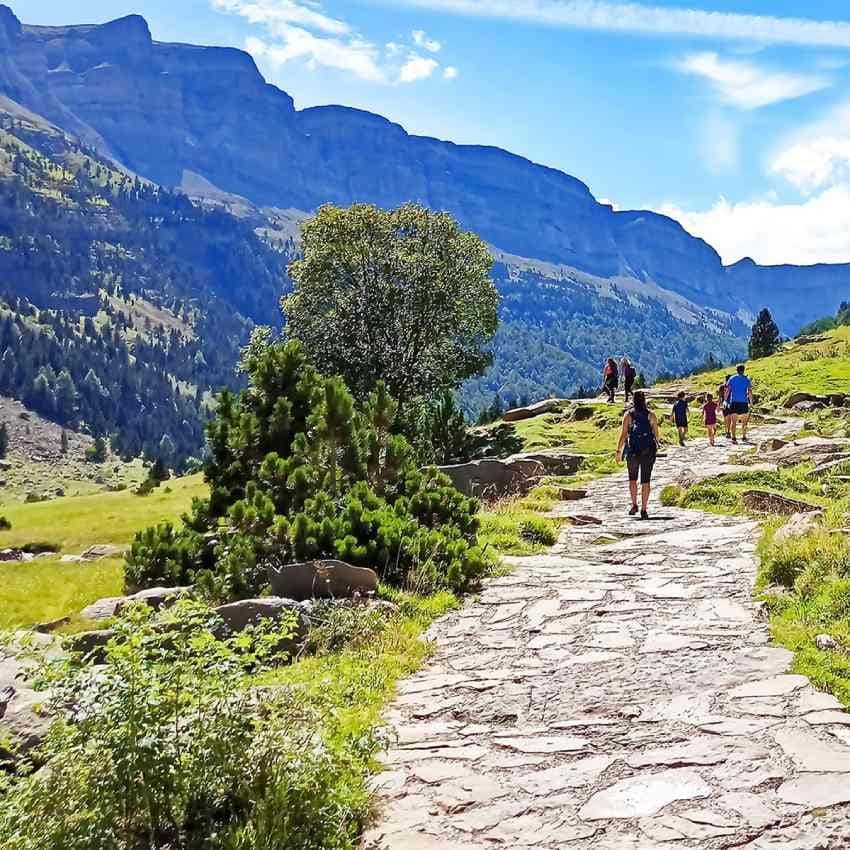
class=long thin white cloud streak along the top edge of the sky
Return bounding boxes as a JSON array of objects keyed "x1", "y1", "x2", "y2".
[{"x1": 385, "y1": 0, "x2": 850, "y2": 48}]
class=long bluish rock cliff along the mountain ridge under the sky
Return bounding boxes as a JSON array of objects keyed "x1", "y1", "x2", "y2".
[{"x1": 0, "y1": 6, "x2": 843, "y2": 329}]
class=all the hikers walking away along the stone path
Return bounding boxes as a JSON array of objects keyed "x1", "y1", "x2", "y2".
[{"x1": 603, "y1": 358, "x2": 753, "y2": 519}]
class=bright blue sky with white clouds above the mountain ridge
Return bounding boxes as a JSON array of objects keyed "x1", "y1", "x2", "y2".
[{"x1": 13, "y1": 0, "x2": 850, "y2": 264}]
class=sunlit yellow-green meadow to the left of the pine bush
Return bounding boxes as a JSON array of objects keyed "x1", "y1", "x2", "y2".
[{"x1": 0, "y1": 475, "x2": 206, "y2": 629}]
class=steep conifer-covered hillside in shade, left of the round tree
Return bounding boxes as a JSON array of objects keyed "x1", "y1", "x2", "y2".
[{"x1": 0, "y1": 110, "x2": 289, "y2": 464}]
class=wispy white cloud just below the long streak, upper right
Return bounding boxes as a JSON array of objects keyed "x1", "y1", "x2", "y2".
[{"x1": 675, "y1": 51, "x2": 832, "y2": 109}]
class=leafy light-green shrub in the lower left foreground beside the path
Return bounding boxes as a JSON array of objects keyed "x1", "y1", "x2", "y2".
[{"x1": 0, "y1": 602, "x2": 375, "y2": 850}]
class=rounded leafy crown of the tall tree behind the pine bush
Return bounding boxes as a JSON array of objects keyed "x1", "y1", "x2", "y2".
[{"x1": 283, "y1": 204, "x2": 499, "y2": 416}]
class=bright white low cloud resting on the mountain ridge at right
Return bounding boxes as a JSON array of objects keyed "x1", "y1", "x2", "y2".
[{"x1": 658, "y1": 183, "x2": 850, "y2": 265}]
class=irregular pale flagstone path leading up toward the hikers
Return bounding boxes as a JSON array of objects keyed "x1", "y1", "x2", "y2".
[{"x1": 364, "y1": 426, "x2": 850, "y2": 850}]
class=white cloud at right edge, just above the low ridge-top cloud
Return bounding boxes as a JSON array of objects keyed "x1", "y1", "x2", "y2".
[{"x1": 768, "y1": 103, "x2": 850, "y2": 194}]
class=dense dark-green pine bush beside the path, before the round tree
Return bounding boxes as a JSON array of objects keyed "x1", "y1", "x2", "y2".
[{"x1": 127, "y1": 329, "x2": 488, "y2": 599}]
